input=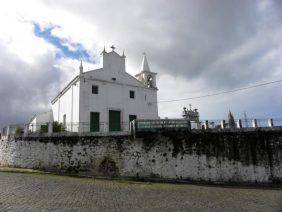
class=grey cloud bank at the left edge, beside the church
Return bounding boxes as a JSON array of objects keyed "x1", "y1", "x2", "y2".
[{"x1": 0, "y1": 42, "x2": 60, "y2": 127}]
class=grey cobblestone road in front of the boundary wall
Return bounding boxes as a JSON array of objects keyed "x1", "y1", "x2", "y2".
[{"x1": 0, "y1": 172, "x2": 282, "y2": 212}]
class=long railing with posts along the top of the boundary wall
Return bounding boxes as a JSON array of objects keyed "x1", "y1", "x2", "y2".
[{"x1": 1, "y1": 118, "x2": 282, "y2": 136}]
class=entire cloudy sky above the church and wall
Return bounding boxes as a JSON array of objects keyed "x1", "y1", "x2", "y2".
[{"x1": 0, "y1": 0, "x2": 282, "y2": 127}]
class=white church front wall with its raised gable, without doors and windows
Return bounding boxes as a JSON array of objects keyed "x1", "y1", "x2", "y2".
[{"x1": 80, "y1": 52, "x2": 158, "y2": 131}]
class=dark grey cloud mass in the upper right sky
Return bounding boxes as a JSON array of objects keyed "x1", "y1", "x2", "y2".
[{"x1": 140, "y1": 0, "x2": 281, "y2": 88}]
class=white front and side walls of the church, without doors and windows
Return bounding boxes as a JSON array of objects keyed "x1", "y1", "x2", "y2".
[{"x1": 49, "y1": 52, "x2": 158, "y2": 132}]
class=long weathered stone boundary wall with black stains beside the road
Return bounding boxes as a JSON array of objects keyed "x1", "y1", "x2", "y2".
[{"x1": 0, "y1": 130, "x2": 282, "y2": 184}]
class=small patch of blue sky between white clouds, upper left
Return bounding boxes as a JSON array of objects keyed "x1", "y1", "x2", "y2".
[{"x1": 33, "y1": 23, "x2": 95, "y2": 63}]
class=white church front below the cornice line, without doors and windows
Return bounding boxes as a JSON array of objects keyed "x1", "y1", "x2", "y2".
[{"x1": 80, "y1": 76, "x2": 158, "y2": 131}]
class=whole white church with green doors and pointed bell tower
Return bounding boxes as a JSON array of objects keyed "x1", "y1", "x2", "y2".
[{"x1": 31, "y1": 46, "x2": 158, "y2": 132}]
